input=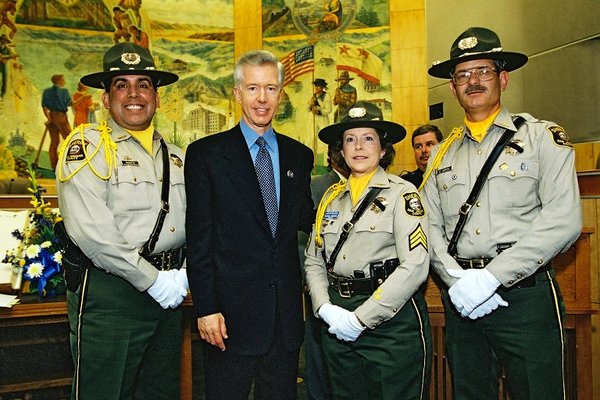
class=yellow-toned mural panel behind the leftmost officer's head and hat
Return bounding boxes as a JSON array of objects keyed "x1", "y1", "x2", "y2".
[{"x1": 0, "y1": 0, "x2": 234, "y2": 178}]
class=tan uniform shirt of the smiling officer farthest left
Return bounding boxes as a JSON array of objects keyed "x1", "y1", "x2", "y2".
[{"x1": 57, "y1": 119, "x2": 186, "y2": 291}]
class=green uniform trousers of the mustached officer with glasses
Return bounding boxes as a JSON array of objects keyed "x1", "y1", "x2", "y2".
[{"x1": 442, "y1": 269, "x2": 566, "y2": 400}]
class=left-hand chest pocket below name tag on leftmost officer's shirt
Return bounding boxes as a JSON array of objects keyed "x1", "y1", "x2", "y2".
[{"x1": 110, "y1": 166, "x2": 160, "y2": 212}]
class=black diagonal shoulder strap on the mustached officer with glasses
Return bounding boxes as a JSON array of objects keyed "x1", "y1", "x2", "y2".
[{"x1": 448, "y1": 116, "x2": 525, "y2": 257}]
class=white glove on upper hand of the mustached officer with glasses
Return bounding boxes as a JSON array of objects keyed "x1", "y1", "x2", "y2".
[{"x1": 446, "y1": 268, "x2": 500, "y2": 317}]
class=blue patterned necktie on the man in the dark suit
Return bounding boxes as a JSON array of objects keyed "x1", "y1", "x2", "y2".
[{"x1": 254, "y1": 136, "x2": 278, "y2": 237}]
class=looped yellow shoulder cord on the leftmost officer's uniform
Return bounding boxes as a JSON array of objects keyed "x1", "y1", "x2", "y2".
[{"x1": 57, "y1": 120, "x2": 117, "y2": 182}]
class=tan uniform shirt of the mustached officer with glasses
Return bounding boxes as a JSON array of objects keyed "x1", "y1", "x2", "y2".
[{"x1": 423, "y1": 108, "x2": 581, "y2": 287}]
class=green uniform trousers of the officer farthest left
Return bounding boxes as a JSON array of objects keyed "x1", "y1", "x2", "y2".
[{"x1": 67, "y1": 268, "x2": 182, "y2": 400}]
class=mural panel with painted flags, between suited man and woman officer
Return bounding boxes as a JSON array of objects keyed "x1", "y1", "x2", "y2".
[{"x1": 263, "y1": 0, "x2": 392, "y2": 173}]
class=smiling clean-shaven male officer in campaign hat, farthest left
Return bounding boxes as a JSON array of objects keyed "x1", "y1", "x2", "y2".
[{"x1": 57, "y1": 43, "x2": 187, "y2": 400}]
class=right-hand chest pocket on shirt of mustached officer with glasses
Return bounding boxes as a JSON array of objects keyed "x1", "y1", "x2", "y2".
[{"x1": 487, "y1": 158, "x2": 540, "y2": 210}]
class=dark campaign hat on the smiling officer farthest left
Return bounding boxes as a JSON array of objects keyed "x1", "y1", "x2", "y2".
[{"x1": 81, "y1": 42, "x2": 179, "y2": 89}]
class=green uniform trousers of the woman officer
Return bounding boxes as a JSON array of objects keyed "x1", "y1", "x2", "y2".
[{"x1": 323, "y1": 290, "x2": 432, "y2": 400}]
